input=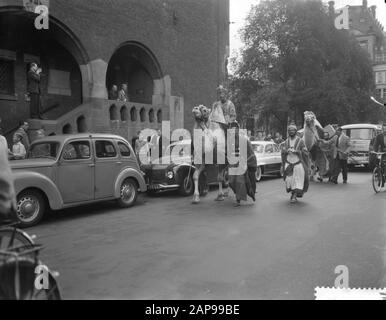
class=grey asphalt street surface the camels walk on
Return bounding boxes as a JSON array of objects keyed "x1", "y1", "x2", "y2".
[{"x1": 27, "y1": 171, "x2": 386, "y2": 299}]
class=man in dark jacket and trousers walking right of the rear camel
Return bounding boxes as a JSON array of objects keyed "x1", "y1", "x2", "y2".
[{"x1": 331, "y1": 127, "x2": 351, "y2": 184}]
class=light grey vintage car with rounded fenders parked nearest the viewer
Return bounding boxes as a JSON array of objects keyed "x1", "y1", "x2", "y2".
[{"x1": 11, "y1": 134, "x2": 146, "y2": 227}]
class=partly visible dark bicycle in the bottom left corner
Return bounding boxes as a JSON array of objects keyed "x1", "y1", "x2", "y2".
[{"x1": 0, "y1": 215, "x2": 61, "y2": 300}]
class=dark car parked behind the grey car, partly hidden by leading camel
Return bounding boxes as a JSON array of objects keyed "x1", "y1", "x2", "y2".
[{"x1": 141, "y1": 140, "x2": 228, "y2": 196}]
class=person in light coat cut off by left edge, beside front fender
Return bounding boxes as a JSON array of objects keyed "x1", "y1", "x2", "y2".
[{"x1": 0, "y1": 135, "x2": 16, "y2": 219}]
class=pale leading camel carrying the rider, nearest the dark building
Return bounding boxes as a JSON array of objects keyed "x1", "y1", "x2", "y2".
[{"x1": 192, "y1": 105, "x2": 228, "y2": 204}]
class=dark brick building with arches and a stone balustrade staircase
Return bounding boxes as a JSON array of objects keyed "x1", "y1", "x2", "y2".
[{"x1": 0, "y1": 0, "x2": 229, "y2": 140}]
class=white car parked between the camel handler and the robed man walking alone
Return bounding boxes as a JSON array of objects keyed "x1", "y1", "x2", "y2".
[{"x1": 251, "y1": 141, "x2": 283, "y2": 181}]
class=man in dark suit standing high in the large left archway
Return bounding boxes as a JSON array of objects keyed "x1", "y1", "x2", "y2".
[{"x1": 27, "y1": 62, "x2": 43, "y2": 119}]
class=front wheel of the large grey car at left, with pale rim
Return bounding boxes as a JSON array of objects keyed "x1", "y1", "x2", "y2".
[{"x1": 16, "y1": 190, "x2": 46, "y2": 227}]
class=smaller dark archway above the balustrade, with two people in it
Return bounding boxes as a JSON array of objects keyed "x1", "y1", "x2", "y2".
[{"x1": 106, "y1": 42, "x2": 163, "y2": 104}]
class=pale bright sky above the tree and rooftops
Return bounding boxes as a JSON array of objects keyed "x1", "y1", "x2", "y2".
[{"x1": 230, "y1": 0, "x2": 386, "y2": 56}]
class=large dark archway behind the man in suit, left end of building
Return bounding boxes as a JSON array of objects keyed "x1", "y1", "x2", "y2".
[{"x1": 0, "y1": 6, "x2": 91, "y2": 131}]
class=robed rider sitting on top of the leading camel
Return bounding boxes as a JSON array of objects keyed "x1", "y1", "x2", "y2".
[{"x1": 210, "y1": 86, "x2": 236, "y2": 129}]
